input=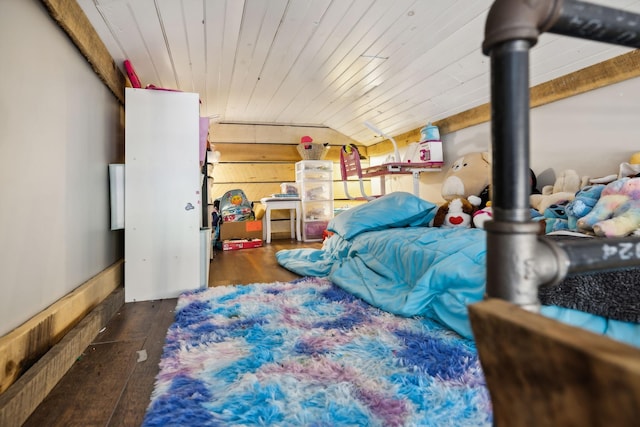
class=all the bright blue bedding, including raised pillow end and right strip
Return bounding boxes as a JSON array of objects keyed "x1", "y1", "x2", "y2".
[{"x1": 276, "y1": 192, "x2": 640, "y2": 346}]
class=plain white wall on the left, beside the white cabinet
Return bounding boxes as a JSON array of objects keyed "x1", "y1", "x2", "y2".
[{"x1": 0, "y1": 0, "x2": 123, "y2": 335}]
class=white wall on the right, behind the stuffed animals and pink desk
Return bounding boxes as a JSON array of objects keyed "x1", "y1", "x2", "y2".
[{"x1": 372, "y1": 78, "x2": 640, "y2": 203}]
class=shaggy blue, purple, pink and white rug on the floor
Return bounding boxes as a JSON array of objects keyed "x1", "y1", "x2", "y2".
[{"x1": 144, "y1": 278, "x2": 492, "y2": 427}]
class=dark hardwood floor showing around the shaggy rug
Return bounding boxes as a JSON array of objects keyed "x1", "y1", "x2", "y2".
[{"x1": 24, "y1": 240, "x2": 321, "y2": 427}]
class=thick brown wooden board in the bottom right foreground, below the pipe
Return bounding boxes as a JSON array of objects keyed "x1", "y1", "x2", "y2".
[{"x1": 469, "y1": 299, "x2": 640, "y2": 427}]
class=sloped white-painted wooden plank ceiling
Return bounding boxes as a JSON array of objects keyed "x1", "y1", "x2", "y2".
[{"x1": 78, "y1": 0, "x2": 640, "y2": 145}]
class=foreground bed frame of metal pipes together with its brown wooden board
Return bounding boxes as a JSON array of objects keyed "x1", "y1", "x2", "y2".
[{"x1": 469, "y1": 0, "x2": 640, "y2": 427}]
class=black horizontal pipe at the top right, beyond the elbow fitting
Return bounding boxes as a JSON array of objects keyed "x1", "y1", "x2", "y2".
[{"x1": 547, "y1": 0, "x2": 640, "y2": 48}]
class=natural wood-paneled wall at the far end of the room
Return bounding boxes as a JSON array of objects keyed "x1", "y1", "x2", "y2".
[{"x1": 209, "y1": 123, "x2": 370, "y2": 239}]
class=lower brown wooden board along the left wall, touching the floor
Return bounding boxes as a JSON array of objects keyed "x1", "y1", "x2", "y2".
[{"x1": 0, "y1": 288, "x2": 124, "y2": 427}]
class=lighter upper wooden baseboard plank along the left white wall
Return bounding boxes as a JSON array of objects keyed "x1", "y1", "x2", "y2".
[{"x1": 0, "y1": 260, "x2": 124, "y2": 396}]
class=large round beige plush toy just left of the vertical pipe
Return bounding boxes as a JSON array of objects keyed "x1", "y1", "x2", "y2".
[{"x1": 441, "y1": 152, "x2": 491, "y2": 201}]
